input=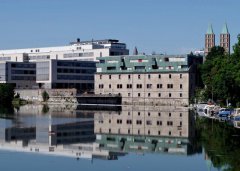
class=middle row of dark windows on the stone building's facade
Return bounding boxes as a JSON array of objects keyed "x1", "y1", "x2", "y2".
[{"x1": 98, "y1": 84, "x2": 183, "y2": 89}]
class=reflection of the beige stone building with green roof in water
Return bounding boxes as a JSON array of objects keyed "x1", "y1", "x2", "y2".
[{"x1": 94, "y1": 107, "x2": 195, "y2": 155}]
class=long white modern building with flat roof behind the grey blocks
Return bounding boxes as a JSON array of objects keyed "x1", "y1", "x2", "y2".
[{"x1": 0, "y1": 39, "x2": 129, "y2": 62}]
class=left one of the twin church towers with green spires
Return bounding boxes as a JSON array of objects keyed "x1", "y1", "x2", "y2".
[{"x1": 204, "y1": 24, "x2": 215, "y2": 55}]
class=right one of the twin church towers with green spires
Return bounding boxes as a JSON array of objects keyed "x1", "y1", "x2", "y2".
[{"x1": 220, "y1": 23, "x2": 230, "y2": 54}]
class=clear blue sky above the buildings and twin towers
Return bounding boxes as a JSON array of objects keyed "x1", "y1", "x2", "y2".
[{"x1": 0, "y1": 0, "x2": 240, "y2": 54}]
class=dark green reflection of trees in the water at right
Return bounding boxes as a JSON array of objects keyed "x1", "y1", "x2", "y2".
[{"x1": 196, "y1": 118, "x2": 240, "y2": 171}]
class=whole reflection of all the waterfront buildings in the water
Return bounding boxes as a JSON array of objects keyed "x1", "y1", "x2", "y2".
[{"x1": 0, "y1": 106, "x2": 195, "y2": 160}]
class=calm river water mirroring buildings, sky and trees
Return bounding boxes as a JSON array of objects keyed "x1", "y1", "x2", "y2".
[{"x1": 0, "y1": 105, "x2": 240, "y2": 171}]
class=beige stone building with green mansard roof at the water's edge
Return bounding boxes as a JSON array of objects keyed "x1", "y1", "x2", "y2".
[{"x1": 95, "y1": 55, "x2": 202, "y2": 105}]
